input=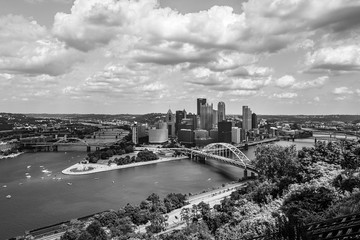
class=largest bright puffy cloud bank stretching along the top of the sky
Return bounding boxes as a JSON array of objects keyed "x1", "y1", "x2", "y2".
[{"x1": 53, "y1": 0, "x2": 360, "y2": 53}]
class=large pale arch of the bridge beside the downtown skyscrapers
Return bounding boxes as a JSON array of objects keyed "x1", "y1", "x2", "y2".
[{"x1": 202, "y1": 143, "x2": 250, "y2": 169}]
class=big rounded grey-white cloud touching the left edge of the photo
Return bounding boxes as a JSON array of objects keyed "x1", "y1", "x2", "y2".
[{"x1": 0, "y1": 15, "x2": 81, "y2": 76}]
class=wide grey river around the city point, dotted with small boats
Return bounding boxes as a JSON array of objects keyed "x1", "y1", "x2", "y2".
[{"x1": 0, "y1": 136, "x2": 346, "y2": 239}]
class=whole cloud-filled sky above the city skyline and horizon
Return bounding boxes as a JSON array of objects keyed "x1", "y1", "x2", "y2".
[{"x1": 0, "y1": 0, "x2": 360, "y2": 114}]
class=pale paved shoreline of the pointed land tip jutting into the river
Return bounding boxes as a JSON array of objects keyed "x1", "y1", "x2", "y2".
[{"x1": 61, "y1": 156, "x2": 188, "y2": 175}]
